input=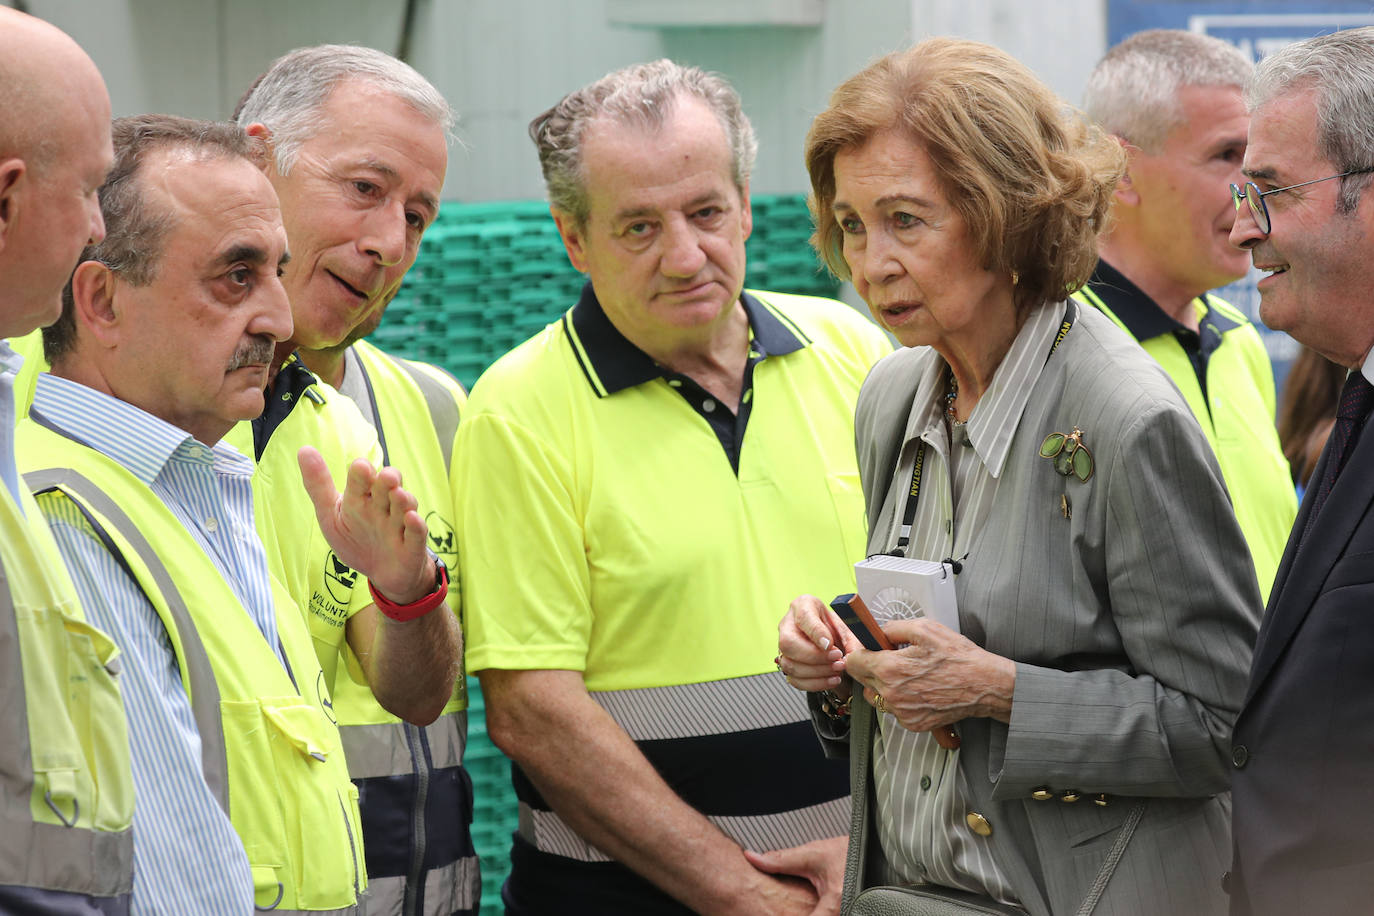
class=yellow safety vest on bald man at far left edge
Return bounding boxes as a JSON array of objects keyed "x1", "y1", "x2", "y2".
[{"x1": 0, "y1": 480, "x2": 133, "y2": 906}]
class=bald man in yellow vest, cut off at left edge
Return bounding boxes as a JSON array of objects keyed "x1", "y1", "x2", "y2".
[{"x1": 0, "y1": 8, "x2": 133, "y2": 915}]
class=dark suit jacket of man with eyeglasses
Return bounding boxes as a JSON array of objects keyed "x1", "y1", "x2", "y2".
[{"x1": 1228, "y1": 395, "x2": 1374, "y2": 916}]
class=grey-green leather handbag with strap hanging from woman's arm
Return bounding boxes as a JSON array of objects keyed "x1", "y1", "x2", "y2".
[{"x1": 840, "y1": 694, "x2": 1145, "y2": 916}]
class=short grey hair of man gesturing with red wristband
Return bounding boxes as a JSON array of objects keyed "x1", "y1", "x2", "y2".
[{"x1": 232, "y1": 44, "x2": 455, "y2": 176}]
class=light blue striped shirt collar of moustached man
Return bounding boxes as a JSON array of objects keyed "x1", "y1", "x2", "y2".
[{"x1": 32, "y1": 374, "x2": 251, "y2": 486}]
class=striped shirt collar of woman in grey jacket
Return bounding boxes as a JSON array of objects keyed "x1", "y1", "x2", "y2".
[{"x1": 907, "y1": 302, "x2": 1063, "y2": 478}]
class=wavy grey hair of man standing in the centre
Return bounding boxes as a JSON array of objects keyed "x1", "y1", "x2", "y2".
[{"x1": 529, "y1": 58, "x2": 758, "y2": 227}]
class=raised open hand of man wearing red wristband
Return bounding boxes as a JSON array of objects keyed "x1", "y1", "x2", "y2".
[{"x1": 297, "y1": 445, "x2": 434, "y2": 604}]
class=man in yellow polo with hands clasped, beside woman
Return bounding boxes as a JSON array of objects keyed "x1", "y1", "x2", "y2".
[{"x1": 455, "y1": 60, "x2": 890, "y2": 916}]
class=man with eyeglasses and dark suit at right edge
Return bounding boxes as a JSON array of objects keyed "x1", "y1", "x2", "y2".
[{"x1": 1227, "y1": 27, "x2": 1374, "y2": 916}]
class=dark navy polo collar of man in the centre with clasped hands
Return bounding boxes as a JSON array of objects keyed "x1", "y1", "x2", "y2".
[{"x1": 563, "y1": 283, "x2": 811, "y2": 397}]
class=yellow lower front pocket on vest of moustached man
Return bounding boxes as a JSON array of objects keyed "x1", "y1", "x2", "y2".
[{"x1": 220, "y1": 696, "x2": 361, "y2": 909}]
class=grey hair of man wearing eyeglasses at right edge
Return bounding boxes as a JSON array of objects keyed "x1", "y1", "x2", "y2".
[{"x1": 1245, "y1": 26, "x2": 1374, "y2": 213}]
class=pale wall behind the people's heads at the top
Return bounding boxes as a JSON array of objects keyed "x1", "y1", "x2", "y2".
[{"x1": 21, "y1": 0, "x2": 1105, "y2": 201}]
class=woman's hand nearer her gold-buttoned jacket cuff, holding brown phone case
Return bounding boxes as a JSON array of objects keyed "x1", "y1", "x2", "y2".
[{"x1": 845, "y1": 618, "x2": 1017, "y2": 743}]
